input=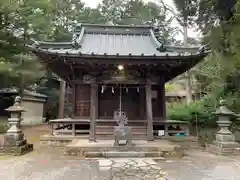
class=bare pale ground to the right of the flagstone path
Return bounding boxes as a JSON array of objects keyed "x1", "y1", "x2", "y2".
[{"x1": 158, "y1": 150, "x2": 240, "y2": 180}]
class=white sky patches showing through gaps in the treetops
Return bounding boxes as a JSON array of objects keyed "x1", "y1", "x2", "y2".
[{"x1": 82, "y1": 0, "x2": 200, "y2": 40}]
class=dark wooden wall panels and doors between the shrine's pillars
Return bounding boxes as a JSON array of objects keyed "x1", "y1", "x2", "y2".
[{"x1": 75, "y1": 84, "x2": 165, "y2": 120}]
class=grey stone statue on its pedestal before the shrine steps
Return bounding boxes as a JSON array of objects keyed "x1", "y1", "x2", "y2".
[{"x1": 114, "y1": 111, "x2": 132, "y2": 146}]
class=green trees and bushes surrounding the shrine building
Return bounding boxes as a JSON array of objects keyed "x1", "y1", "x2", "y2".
[{"x1": 0, "y1": 0, "x2": 240, "y2": 123}]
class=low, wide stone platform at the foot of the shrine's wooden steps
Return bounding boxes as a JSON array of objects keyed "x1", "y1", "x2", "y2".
[{"x1": 65, "y1": 140, "x2": 183, "y2": 158}]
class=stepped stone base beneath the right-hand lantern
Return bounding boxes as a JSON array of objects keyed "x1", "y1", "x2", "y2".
[{"x1": 206, "y1": 141, "x2": 240, "y2": 156}]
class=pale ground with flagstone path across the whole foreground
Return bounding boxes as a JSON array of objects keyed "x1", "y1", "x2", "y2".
[{"x1": 0, "y1": 148, "x2": 240, "y2": 180}]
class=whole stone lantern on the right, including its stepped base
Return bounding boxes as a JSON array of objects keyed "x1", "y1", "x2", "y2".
[{"x1": 207, "y1": 100, "x2": 240, "y2": 155}]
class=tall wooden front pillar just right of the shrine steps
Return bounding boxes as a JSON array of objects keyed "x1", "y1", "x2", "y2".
[{"x1": 146, "y1": 78, "x2": 154, "y2": 141}]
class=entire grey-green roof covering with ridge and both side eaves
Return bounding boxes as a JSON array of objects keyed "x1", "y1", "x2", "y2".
[{"x1": 30, "y1": 24, "x2": 206, "y2": 56}]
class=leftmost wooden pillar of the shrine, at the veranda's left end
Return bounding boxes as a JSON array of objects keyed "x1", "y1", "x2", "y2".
[{"x1": 58, "y1": 79, "x2": 66, "y2": 119}]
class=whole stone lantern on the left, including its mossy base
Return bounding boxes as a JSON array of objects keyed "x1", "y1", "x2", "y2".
[{"x1": 0, "y1": 96, "x2": 33, "y2": 156}]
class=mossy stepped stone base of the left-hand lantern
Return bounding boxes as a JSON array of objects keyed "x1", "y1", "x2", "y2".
[{"x1": 0, "y1": 134, "x2": 33, "y2": 156}]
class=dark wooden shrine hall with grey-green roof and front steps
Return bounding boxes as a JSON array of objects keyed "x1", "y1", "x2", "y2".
[{"x1": 31, "y1": 24, "x2": 207, "y2": 140}]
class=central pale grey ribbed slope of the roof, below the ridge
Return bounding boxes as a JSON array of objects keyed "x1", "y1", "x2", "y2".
[{"x1": 79, "y1": 34, "x2": 165, "y2": 56}]
